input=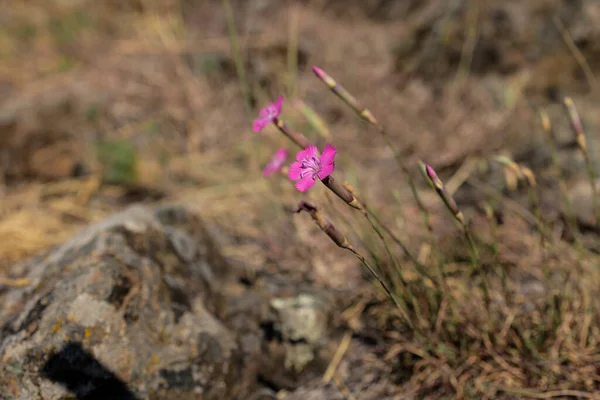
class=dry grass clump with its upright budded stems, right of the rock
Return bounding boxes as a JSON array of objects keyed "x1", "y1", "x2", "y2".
[{"x1": 225, "y1": 2, "x2": 600, "y2": 390}]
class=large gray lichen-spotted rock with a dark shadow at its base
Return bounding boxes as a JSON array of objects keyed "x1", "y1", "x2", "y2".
[{"x1": 0, "y1": 206, "x2": 259, "y2": 400}]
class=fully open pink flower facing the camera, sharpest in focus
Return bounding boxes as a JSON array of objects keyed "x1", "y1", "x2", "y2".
[{"x1": 288, "y1": 144, "x2": 336, "y2": 192}]
